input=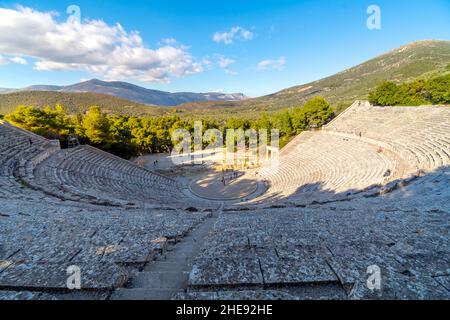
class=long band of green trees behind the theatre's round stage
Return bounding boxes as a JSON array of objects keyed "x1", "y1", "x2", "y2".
[{"x1": 5, "y1": 97, "x2": 334, "y2": 158}]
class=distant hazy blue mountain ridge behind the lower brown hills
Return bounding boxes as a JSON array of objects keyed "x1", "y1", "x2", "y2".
[{"x1": 0, "y1": 79, "x2": 247, "y2": 106}]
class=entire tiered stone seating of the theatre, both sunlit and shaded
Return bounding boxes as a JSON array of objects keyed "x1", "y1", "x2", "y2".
[{"x1": 0, "y1": 104, "x2": 450, "y2": 300}]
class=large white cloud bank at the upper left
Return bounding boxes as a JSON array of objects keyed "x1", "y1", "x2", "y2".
[{"x1": 0, "y1": 7, "x2": 203, "y2": 82}]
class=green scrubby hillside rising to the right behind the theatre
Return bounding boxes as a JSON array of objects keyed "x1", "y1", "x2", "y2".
[{"x1": 178, "y1": 40, "x2": 450, "y2": 113}]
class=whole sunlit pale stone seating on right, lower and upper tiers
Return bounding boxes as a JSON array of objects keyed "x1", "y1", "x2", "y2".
[{"x1": 253, "y1": 102, "x2": 450, "y2": 203}]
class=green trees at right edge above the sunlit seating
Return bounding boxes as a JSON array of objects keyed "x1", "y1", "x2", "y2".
[{"x1": 369, "y1": 74, "x2": 450, "y2": 106}]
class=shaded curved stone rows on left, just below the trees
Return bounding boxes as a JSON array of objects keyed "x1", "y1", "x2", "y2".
[{"x1": 0, "y1": 122, "x2": 206, "y2": 208}]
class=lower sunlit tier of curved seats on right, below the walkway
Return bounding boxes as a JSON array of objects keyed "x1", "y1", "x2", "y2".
[{"x1": 258, "y1": 132, "x2": 398, "y2": 201}]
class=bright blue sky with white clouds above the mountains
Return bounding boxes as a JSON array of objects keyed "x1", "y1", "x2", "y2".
[{"x1": 0, "y1": 0, "x2": 450, "y2": 96}]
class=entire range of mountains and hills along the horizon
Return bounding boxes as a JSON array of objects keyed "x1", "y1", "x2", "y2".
[{"x1": 0, "y1": 40, "x2": 450, "y2": 118}]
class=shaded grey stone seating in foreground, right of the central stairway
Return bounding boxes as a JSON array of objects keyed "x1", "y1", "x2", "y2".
[{"x1": 182, "y1": 169, "x2": 450, "y2": 299}]
